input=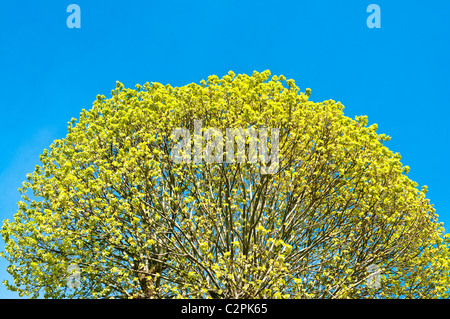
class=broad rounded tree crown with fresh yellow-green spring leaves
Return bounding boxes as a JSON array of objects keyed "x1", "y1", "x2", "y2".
[{"x1": 2, "y1": 71, "x2": 449, "y2": 298}]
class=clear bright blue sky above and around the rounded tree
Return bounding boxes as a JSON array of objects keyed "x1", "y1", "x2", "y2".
[{"x1": 0, "y1": 0, "x2": 450, "y2": 298}]
